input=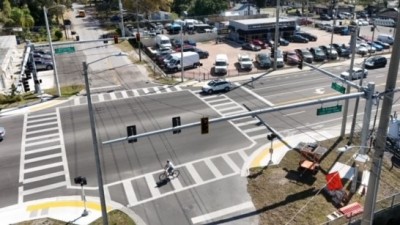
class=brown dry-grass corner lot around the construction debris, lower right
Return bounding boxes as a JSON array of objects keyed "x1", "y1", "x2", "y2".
[{"x1": 247, "y1": 134, "x2": 400, "y2": 225}]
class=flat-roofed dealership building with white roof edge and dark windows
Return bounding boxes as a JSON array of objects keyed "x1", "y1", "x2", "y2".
[{"x1": 229, "y1": 17, "x2": 297, "y2": 42}]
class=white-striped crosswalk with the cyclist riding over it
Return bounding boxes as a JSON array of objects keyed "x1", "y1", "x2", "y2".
[{"x1": 105, "y1": 150, "x2": 248, "y2": 207}]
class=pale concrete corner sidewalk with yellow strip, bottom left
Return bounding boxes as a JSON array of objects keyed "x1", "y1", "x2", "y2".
[{"x1": 0, "y1": 196, "x2": 145, "y2": 225}]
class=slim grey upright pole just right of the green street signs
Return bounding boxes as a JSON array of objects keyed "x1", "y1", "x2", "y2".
[{"x1": 340, "y1": 12, "x2": 358, "y2": 137}]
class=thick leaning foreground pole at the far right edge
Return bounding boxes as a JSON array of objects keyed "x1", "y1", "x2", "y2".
[{"x1": 361, "y1": 9, "x2": 400, "y2": 225}]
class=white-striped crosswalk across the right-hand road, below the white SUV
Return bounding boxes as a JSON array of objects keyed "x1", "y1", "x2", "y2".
[{"x1": 193, "y1": 92, "x2": 270, "y2": 141}]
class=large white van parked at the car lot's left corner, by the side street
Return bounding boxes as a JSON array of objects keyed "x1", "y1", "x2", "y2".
[{"x1": 167, "y1": 52, "x2": 201, "y2": 72}]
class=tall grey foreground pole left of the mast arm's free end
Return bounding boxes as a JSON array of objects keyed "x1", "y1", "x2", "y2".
[{"x1": 82, "y1": 62, "x2": 108, "y2": 225}]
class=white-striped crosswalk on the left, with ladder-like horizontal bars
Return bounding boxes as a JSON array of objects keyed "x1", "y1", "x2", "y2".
[{"x1": 19, "y1": 111, "x2": 69, "y2": 203}]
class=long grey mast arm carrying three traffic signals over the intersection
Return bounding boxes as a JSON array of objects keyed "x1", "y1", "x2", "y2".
[{"x1": 102, "y1": 92, "x2": 365, "y2": 145}]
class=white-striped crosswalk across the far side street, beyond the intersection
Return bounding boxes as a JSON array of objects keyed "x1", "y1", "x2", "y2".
[{"x1": 73, "y1": 85, "x2": 182, "y2": 105}]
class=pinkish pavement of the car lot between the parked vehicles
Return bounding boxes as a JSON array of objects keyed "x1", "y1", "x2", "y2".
[{"x1": 166, "y1": 23, "x2": 393, "y2": 80}]
